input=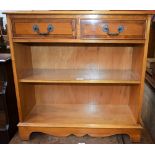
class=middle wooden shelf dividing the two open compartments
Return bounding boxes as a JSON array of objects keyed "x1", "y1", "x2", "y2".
[{"x1": 19, "y1": 69, "x2": 140, "y2": 84}]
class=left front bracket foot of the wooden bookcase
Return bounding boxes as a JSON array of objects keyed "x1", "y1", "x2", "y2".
[{"x1": 18, "y1": 127, "x2": 31, "y2": 140}]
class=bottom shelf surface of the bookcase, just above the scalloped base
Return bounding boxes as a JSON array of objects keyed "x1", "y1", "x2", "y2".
[{"x1": 22, "y1": 103, "x2": 137, "y2": 128}]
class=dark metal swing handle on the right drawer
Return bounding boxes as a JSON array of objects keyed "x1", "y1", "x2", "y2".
[{"x1": 102, "y1": 25, "x2": 124, "y2": 36}]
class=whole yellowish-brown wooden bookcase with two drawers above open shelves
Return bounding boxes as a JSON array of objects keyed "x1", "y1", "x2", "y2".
[{"x1": 6, "y1": 11, "x2": 152, "y2": 141}]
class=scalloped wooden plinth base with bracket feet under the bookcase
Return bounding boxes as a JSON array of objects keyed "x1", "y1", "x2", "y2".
[{"x1": 18, "y1": 123, "x2": 142, "y2": 142}]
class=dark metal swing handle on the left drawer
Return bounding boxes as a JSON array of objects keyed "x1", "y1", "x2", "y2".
[{"x1": 33, "y1": 24, "x2": 54, "y2": 35}]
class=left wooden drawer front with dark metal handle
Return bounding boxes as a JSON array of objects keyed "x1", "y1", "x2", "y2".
[{"x1": 13, "y1": 18, "x2": 76, "y2": 38}]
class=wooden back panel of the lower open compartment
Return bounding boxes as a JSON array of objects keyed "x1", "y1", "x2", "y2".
[{"x1": 35, "y1": 84, "x2": 132, "y2": 107}]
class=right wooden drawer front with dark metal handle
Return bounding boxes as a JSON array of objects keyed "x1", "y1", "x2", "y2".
[{"x1": 80, "y1": 19, "x2": 146, "y2": 39}]
